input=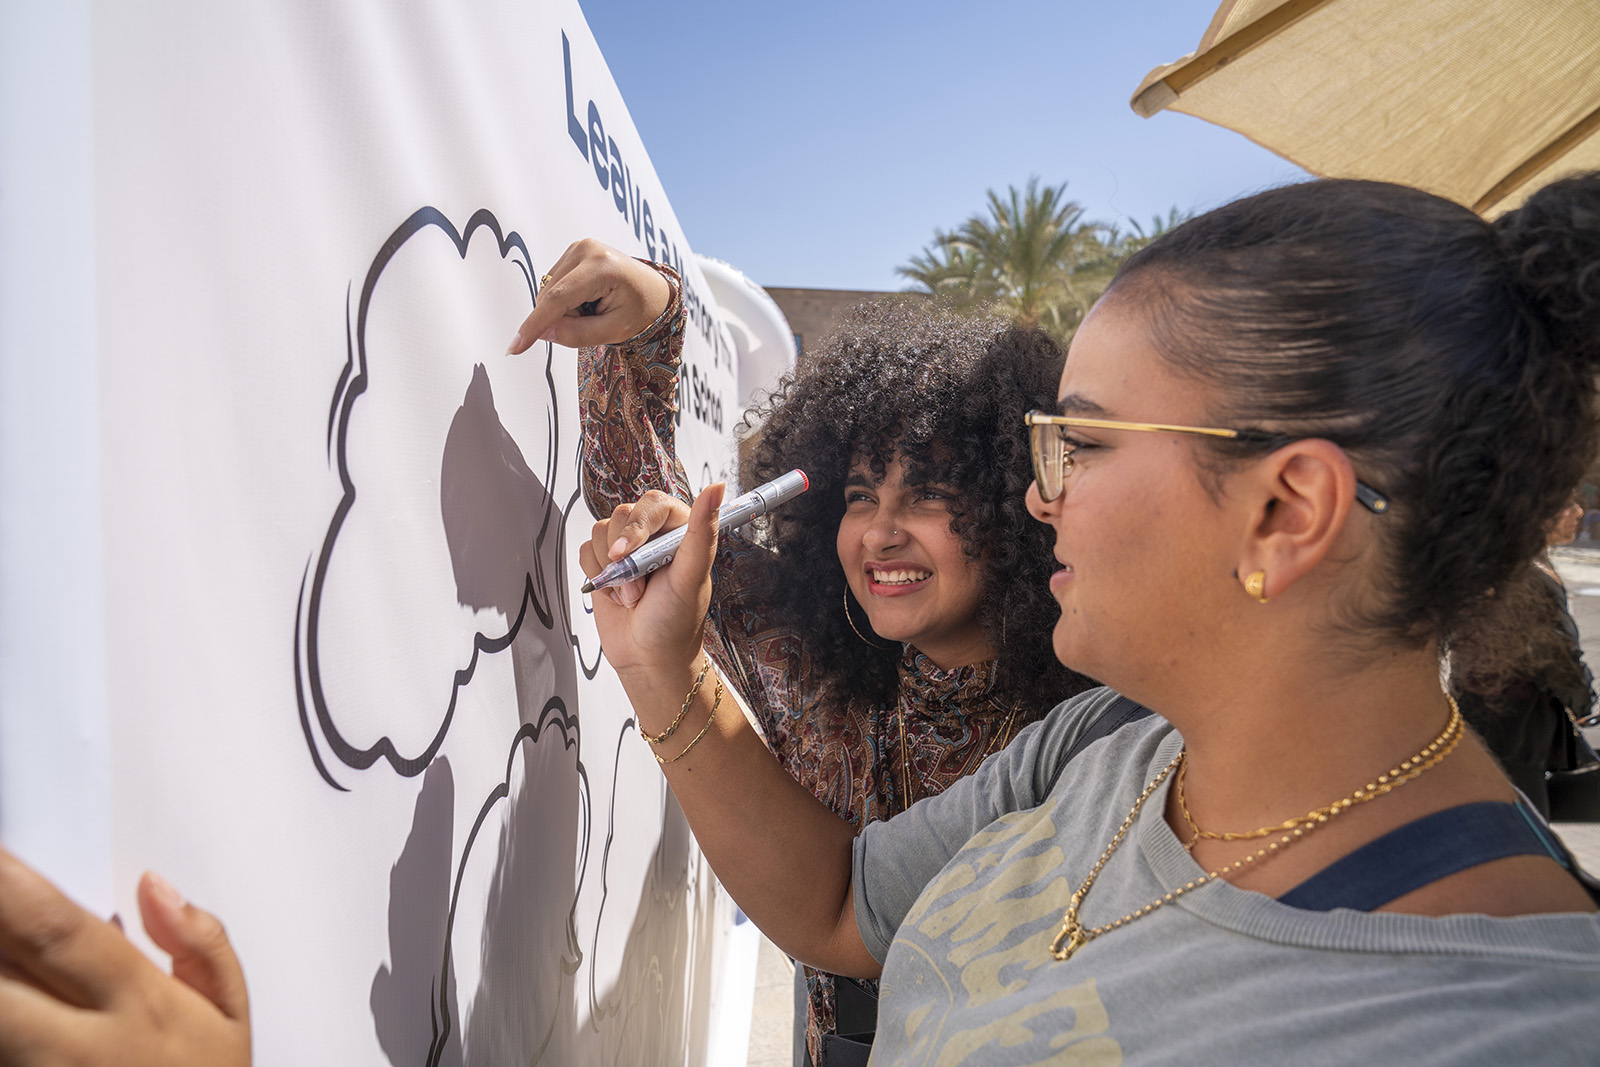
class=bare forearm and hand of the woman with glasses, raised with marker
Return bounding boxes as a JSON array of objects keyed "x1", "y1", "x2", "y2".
[{"x1": 578, "y1": 485, "x2": 882, "y2": 977}]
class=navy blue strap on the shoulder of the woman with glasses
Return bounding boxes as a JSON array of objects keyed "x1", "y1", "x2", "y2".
[{"x1": 1278, "y1": 801, "x2": 1574, "y2": 912}]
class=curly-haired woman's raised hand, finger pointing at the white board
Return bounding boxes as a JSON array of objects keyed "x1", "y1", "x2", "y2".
[{"x1": 506, "y1": 237, "x2": 672, "y2": 355}]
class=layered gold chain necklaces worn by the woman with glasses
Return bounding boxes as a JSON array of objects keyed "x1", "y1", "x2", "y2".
[{"x1": 1050, "y1": 694, "x2": 1464, "y2": 960}]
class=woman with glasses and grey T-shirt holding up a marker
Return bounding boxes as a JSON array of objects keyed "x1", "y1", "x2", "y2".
[{"x1": 581, "y1": 176, "x2": 1600, "y2": 1064}]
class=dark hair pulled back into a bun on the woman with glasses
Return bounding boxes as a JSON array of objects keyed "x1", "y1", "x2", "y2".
[{"x1": 1110, "y1": 174, "x2": 1600, "y2": 659}]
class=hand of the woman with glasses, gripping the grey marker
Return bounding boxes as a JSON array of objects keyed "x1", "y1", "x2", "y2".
[{"x1": 578, "y1": 482, "x2": 725, "y2": 683}]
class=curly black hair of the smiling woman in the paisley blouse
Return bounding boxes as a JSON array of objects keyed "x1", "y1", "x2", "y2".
[{"x1": 741, "y1": 299, "x2": 1093, "y2": 718}]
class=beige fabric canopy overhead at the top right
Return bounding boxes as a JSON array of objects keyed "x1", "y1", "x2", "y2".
[{"x1": 1133, "y1": 0, "x2": 1600, "y2": 216}]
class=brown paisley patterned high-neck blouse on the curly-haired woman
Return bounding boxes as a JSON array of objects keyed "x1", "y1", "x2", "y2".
[{"x1": 578, "y1": 264, "x2": 1048, "y2": 1062}]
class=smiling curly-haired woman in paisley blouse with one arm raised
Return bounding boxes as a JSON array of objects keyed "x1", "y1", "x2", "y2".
[{"x1": 512, "y1": 242, "x2": 1088, "y2": 1062}]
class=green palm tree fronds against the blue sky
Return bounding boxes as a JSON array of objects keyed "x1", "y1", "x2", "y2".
[{"x1": 896, "y1": 176, "x2": 1187, "y2": 341}]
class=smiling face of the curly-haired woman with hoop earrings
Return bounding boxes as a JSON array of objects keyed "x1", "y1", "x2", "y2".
[{"x1": 837, "y1": 458, "x2": 995, "y2": 670}]
